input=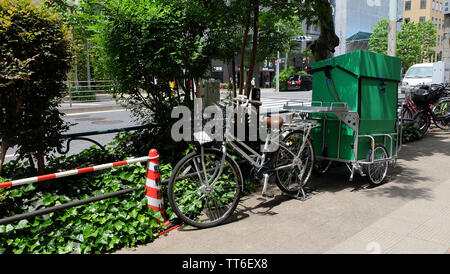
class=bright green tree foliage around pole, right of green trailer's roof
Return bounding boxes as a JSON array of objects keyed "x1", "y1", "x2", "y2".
[{"x1": 369, "y1": 19, "x2": 436, "y2": 71}]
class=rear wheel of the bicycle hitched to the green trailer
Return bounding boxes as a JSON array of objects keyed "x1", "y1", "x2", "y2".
[{"x1": 275, "y1": 131, "x2": 314, "y2": 195}]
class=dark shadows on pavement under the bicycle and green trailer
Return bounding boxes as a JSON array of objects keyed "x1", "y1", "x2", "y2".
[{"x1": 174, "y1": 130, "x2": 450, "y2": 231}]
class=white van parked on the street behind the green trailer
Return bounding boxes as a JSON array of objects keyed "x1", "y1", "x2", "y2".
[{"x1": 402, "y1": 63, "x2": 433, "y2": 92}]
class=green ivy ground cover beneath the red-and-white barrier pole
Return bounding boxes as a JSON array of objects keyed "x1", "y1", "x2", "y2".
[{"x1": 0, "y1": 144, "x2": 172, "y2": 254}]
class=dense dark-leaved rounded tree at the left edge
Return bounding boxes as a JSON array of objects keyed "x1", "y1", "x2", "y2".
[{"x1": 0, "y1": 0, "x2": 72, "y2": 173}]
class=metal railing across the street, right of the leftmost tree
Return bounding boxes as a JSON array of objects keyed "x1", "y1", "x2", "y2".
[{"x1": 62, "y1": 80, "x2": 114, "y2": 107}]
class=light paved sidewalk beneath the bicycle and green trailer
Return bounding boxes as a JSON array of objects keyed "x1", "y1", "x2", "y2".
[{"x1": 117, "y1": 130, "x2": 450, "y2": 254}]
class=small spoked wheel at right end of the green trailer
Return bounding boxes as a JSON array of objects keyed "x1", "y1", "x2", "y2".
[{"x1": 365, "y1": 144, "x2": 389, "y2": 185}]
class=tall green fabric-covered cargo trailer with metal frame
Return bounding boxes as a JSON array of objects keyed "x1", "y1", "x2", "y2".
[{"x1": 284, "y1": 50, "x2": 401, "y2": 184}]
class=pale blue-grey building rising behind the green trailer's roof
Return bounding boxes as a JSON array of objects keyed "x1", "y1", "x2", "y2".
[{"x1": 333, "y1": 0, "x2": 404, "y2": 56}]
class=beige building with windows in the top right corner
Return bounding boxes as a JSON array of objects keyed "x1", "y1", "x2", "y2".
[{"x1": 403, "y1": 0, "x2": 444, "y2": 62}]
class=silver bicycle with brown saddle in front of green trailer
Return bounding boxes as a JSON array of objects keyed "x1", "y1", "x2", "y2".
[{"x1": 168, "y1": 97, "x2": 316, "y2": 228}]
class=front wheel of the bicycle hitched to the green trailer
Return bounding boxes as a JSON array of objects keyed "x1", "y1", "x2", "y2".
[{"x1": 168, "y1": 149, "x2": 243, "y2": 228}]
